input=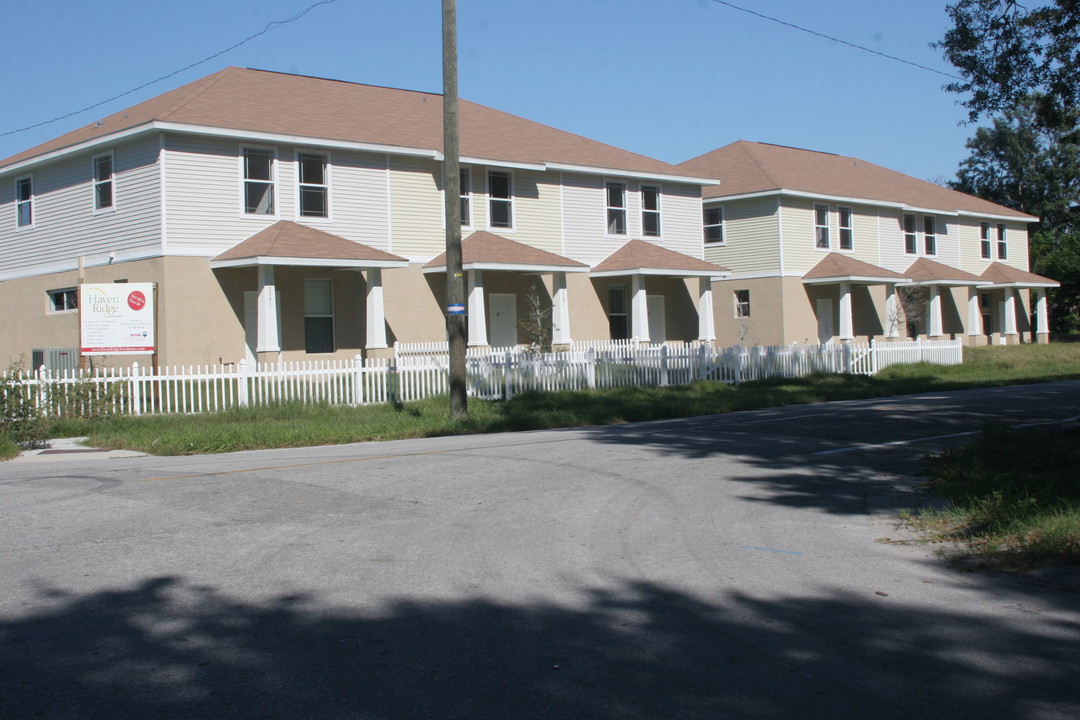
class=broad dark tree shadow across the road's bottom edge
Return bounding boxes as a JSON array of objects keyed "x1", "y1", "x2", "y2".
[{"x1": 0, "y1": 578, "x2": 1080, "y2": 720}]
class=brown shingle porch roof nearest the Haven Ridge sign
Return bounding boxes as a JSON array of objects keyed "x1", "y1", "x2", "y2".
[{"x1": 214, "y1": 220, "x2": 408, "y2": 267}]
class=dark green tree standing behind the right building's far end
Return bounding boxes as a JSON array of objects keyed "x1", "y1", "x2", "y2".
[{"x1": 949, "y1": 95, "x2": 1080, "y2": 332}]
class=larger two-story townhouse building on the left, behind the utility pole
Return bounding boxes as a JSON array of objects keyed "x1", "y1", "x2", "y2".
[{"x1": 0, "y1": 68, "x2": 725, "y2": 364}]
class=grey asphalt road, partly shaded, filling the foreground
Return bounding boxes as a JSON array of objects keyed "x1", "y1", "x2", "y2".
[{"x1": 0, "y1": 382, "x2": 1080, "y2": 720}]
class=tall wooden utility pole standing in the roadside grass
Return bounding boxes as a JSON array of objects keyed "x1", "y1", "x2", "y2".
[{"x1": 443, "y1": 0, "x2": 468, "y2": 420}]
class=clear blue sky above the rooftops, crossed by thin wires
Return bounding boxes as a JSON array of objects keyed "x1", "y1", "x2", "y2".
[{"x1": 0, "y1": 0, "x2": 974, "y2": 179}]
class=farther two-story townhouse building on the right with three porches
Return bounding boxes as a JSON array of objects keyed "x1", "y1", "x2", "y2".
[{"x1": 679, "y1": 141, "x2": 1057, "y2": 344}]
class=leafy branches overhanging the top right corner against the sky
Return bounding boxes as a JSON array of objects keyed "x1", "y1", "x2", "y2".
[{"x1": 934, "y1": 0, "x2": 1080, "y2": 131}]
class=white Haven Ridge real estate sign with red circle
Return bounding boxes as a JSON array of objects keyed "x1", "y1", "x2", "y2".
[{"x1": 79, "y1": 283, "x2": 154, "y2": 355}]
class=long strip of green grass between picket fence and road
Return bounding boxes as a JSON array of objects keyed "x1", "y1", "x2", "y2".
[{"x1": 10, "y1": 343, "x2": 1080, "y2": 456}]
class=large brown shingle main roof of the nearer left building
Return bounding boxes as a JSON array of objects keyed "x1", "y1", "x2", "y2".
[{"x1": 0, "y1": 67, "x2": 708, "y2": 176}]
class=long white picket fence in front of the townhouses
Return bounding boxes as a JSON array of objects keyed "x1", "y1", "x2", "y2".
[{"x1": 8, "y1": 340, "x2": 963, "y2": 416}]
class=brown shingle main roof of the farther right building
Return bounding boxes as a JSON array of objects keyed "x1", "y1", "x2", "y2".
[{"x1": 679, "y1": 140, "x2": 1036, "y2": 221}]
